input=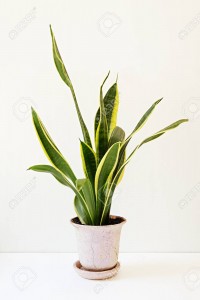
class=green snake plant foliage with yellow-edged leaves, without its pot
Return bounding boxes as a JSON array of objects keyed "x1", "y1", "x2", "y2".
[{"x1": 29, "y1": 27, "x2": 188, "y2": 225}]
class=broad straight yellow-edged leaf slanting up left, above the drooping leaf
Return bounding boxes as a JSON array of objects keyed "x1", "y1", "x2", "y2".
[{"x1": 32, "y1": 108, "x2": 76, "y2": 184}]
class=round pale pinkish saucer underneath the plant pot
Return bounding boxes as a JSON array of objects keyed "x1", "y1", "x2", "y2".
[{"x1": 74, "y1": 260, "x2": 120, "y2": 280}]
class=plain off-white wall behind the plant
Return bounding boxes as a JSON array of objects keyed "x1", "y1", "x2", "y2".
[{"x1": 0, "y1": 0, "x2": 200, "y2": 252}]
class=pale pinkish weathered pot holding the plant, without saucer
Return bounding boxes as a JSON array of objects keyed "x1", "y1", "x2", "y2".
[{"x1": 71, "y1": 216, "x2": 126, "y2": 271}]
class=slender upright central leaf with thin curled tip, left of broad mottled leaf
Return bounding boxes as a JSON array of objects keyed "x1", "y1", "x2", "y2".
[{"x1": 95, "y1": 72, "x2": 110, "y2": 164}]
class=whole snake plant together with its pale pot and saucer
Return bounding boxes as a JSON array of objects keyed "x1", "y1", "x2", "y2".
[{"x1": 29, "y1": 27, "x2": 188, "y2": 279}]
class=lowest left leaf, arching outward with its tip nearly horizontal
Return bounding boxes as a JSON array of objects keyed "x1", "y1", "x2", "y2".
[{"x1": 28, "y1": 165, "x2": 93, "y2": 225}]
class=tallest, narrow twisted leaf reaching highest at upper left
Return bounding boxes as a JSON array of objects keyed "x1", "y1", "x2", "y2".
[{"x1": 50, "y1": 26, "x2": 92, "y2": 147}]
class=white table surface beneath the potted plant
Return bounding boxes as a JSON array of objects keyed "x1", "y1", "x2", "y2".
[{"x1": 0, "y1": 253, "x2": 200, "y2": 300}]
